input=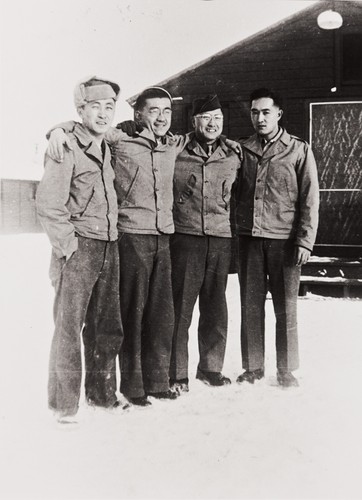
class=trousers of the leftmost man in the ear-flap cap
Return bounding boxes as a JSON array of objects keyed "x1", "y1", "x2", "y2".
[{"x1": 48, "y1": 236, "x2": 123, "y2": 414}]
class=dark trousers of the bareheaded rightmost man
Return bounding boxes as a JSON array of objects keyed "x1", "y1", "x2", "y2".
[{"x1": 239, "y1": 236, "x2": 300, "y2": 371}]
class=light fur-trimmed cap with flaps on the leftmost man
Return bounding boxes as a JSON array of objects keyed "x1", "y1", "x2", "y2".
[{"x1": 74, "y1": 76, "x2": 121, "y2": 108}]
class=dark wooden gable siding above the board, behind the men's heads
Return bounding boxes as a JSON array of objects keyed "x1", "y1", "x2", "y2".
[{"x1": 160, "y1": 1, "x2": 362, "y2": 143}]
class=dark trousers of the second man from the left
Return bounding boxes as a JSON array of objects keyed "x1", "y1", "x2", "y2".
[{"x1": 118, "y1": 233, "x2": 174, "y2": 398}]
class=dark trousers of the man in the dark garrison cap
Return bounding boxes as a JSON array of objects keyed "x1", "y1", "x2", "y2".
[{"x1": 170, "y1": 233, "x2": 231, "y2": 380}]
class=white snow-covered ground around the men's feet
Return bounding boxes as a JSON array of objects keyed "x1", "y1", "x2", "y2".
[{"x1": 0, "y1": 234, "x2": 362, "y2": 500}]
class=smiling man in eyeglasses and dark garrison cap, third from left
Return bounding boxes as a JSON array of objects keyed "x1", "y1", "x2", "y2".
[{"x1": 170, "y1": 95, "x2": 240, "y2": 393}]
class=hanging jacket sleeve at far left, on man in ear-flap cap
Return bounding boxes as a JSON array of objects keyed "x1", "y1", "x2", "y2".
[{"x1": 36, "y1": 147, "x2": 78, "y2": 259}]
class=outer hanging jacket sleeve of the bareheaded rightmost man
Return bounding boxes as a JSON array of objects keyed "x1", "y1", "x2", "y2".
[{"x1": 295, "y1": 143, "x2": 319, "y2": 250}]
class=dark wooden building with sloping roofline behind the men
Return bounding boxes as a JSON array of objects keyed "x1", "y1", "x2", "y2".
[{"x1": 129, "y1": 0, "x2": 362, "y2": 257}]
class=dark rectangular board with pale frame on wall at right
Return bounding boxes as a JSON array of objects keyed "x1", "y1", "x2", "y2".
[{"x1": 310, "y1": 101, "x2": 362, "y2": 249}]
